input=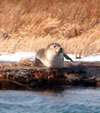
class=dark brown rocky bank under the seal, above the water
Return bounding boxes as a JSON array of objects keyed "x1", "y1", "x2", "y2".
[{"x1": 0, "y1": 62, "x2": 100, "y2": 90}]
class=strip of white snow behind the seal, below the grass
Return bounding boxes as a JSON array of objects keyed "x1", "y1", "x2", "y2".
[{"x1": 0, "y1": 52, "x2": 100, "y2": 62}]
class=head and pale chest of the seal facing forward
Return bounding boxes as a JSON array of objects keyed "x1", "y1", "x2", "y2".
[{"x1": 44, "y1": 43, "x2": 64, "y2": 68}]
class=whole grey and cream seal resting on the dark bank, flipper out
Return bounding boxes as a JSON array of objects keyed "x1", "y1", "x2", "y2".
[{"x1": 35, "y1": 43, "x2": 73, "y2": 68}]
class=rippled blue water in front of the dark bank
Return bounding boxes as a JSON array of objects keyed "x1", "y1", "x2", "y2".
[{"x1": 0, "y1": 88, "x2": 100, "y2": 113}]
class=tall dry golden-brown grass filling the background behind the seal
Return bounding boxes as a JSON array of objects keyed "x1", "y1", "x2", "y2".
[{"x1": 0, "y1": 0, "x2": 100, "y2": 55}]
